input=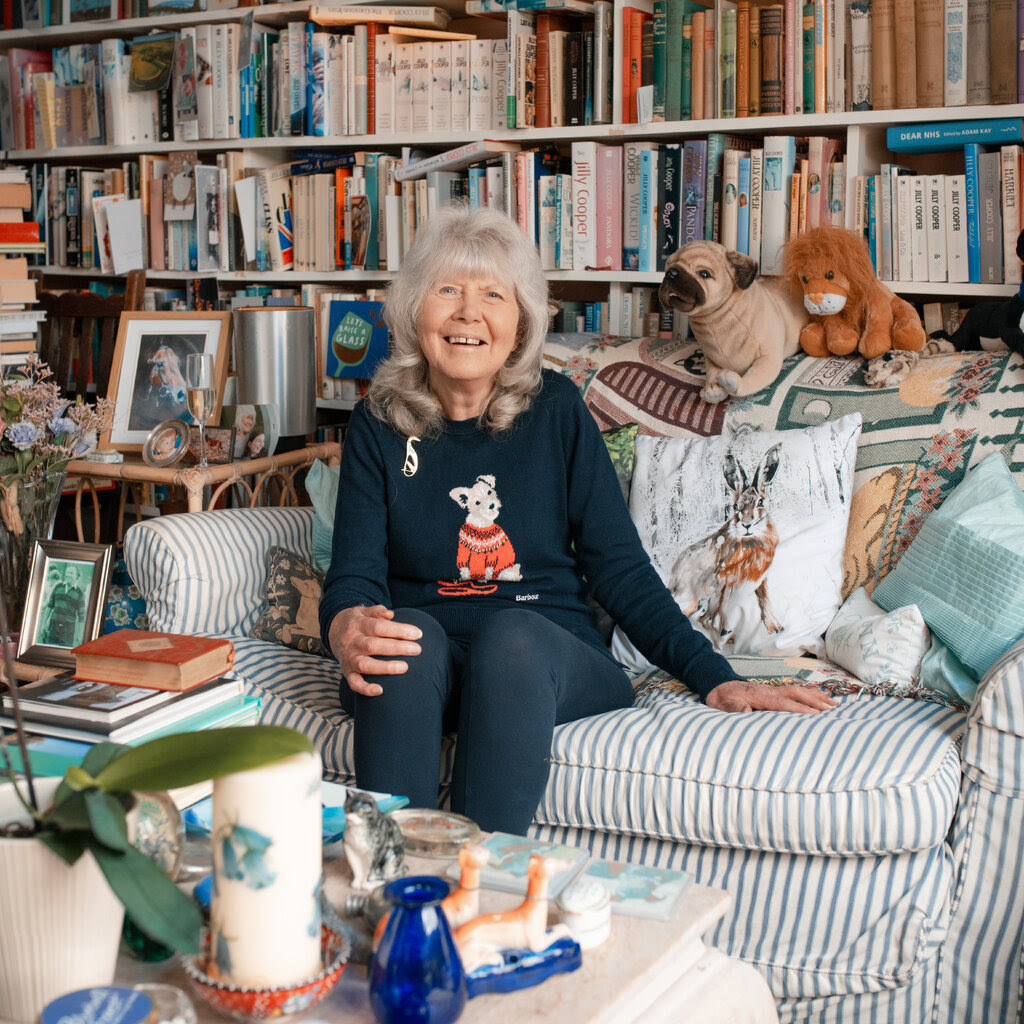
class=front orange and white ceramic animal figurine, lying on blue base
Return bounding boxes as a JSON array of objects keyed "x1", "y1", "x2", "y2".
[{"x1": 455, "y1": 854, "x2": 571, "y2": 974}]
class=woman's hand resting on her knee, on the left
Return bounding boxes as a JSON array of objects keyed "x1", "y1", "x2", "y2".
[{"x1": 328, "y1": 604, "x2": 423, "y2": 697}]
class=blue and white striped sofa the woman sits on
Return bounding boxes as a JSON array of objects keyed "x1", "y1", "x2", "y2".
[{"x1": 125, "y1": 509, "x2": 1024, "y2": 1024}]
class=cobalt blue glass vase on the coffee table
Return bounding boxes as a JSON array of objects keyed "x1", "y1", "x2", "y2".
[{"x1": 370, "y1": 876, "x2": 467, "y2": 1024}]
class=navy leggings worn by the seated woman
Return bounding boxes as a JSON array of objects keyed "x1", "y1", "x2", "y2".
[{"x1": 340, "y1": 608, "x2": 633, "y2": 836}]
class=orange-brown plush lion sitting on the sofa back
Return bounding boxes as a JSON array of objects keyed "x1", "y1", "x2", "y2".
[{"x1": 782, "y1": 225, "x2": 925, "y2": 359}]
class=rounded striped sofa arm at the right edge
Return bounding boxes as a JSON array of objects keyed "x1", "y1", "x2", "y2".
[{"x1": 962, "y1": 640, "x2": 1024, "y2": 799}]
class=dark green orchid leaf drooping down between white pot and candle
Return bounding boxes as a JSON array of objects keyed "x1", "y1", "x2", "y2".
[{"x1": 89, "y1": 844, "x2": 203, "y2": 953}]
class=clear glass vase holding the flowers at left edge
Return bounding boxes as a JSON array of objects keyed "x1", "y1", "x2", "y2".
[{"x1": 0, "y1": 472, "x2": 65, "y2": 634}]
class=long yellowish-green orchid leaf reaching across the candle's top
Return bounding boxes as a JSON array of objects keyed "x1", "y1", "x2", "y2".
[{"x1": 96, "y1": 725, "x2": 313, "y2": 793}]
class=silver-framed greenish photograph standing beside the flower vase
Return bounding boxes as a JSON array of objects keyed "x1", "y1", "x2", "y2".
[{"x1": 17, "y1": 541, "x2": 114, "y2": 669}]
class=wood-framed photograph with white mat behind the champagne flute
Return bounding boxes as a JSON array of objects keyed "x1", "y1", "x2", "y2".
[{"x1": 99, "y1": 311, "x2": 231, "y2": 452}]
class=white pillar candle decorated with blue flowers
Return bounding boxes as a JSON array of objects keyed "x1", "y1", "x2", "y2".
[{"x1": 209, "y1": 754, "x2": 324, "y2": 988}]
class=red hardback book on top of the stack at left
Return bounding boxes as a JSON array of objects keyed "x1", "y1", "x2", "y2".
[{"x1": 72, "y1": 630, "x2": 234, "y2": 690}]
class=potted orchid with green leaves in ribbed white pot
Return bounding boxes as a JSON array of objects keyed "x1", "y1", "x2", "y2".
[{"x1": 0, "y1": 634, "x2": 313, "y2": 1021}]
